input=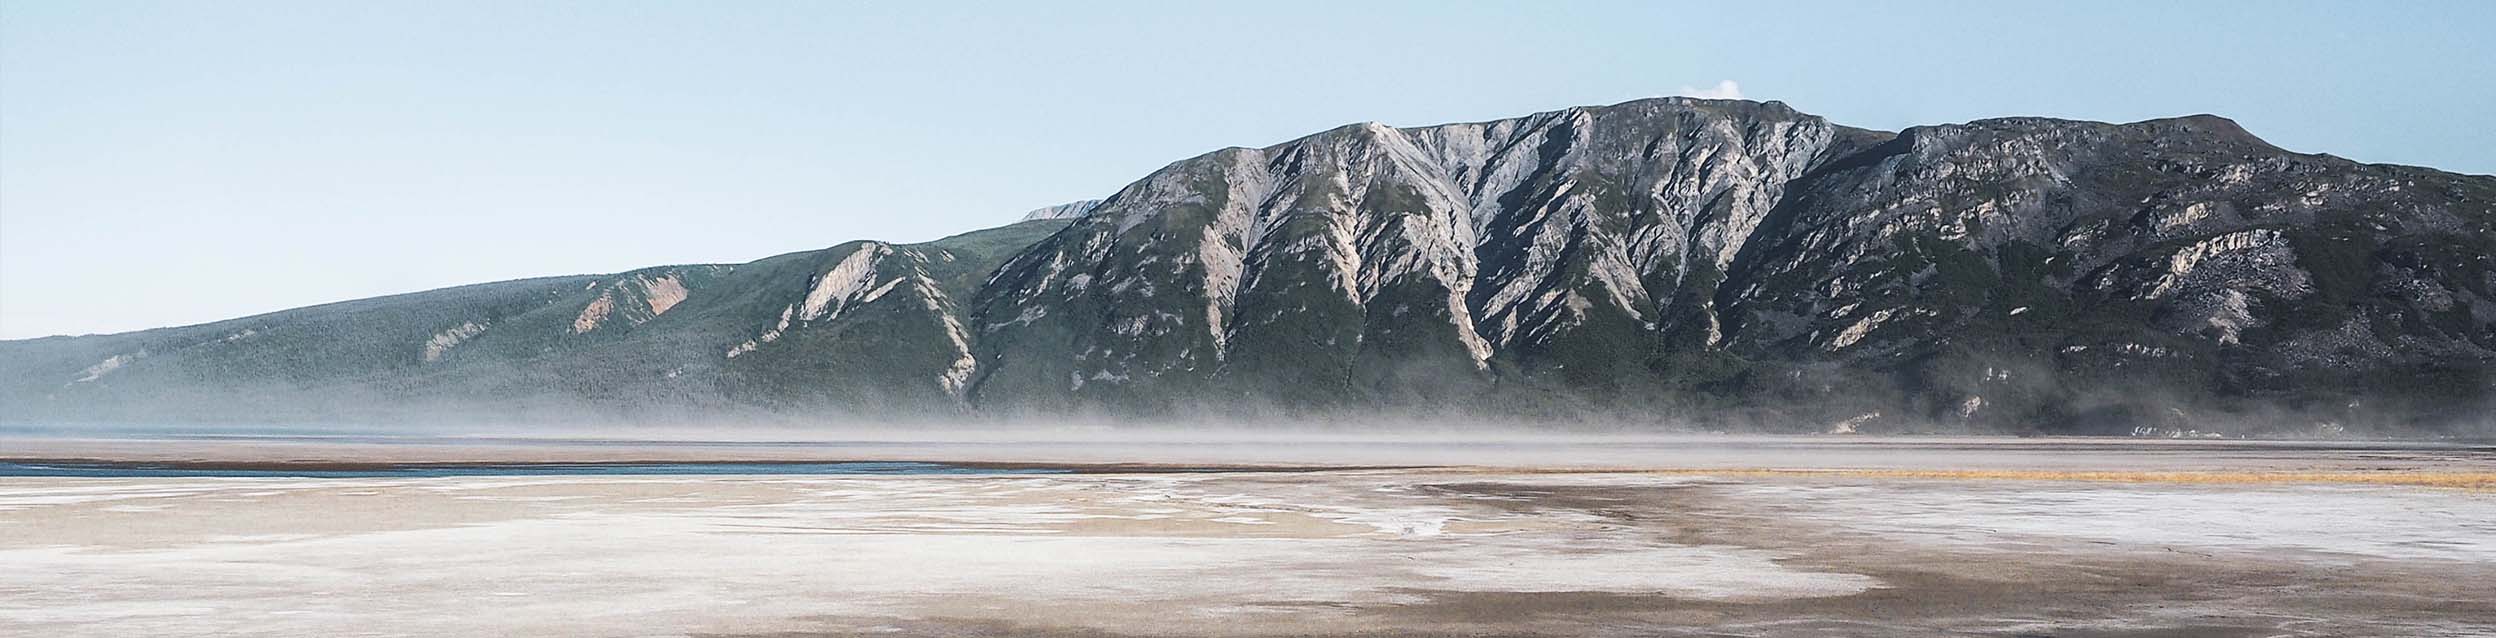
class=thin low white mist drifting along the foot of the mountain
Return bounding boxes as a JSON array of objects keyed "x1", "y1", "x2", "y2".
[{"x1": 0, "y1": 394, "x2": 2496, "y2": 441}]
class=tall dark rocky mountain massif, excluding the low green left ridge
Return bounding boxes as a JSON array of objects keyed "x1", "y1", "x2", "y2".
[{"x1": 973, "y1": 97, "x2": 2496, "y2": 431}]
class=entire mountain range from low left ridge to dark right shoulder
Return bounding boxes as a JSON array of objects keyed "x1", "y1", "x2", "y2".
[{"x1": 0, "y1": 97, "x2": 2496, "y2": 434}]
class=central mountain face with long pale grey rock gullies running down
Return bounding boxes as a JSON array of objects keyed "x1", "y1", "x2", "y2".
[{"x1": 978, "y1": 97, "x2": 1879, "y2": 406}]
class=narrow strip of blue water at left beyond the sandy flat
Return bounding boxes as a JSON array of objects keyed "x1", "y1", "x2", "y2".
[{"x1": 0, "y1": 461, "x2": 1063, "y2": 479}]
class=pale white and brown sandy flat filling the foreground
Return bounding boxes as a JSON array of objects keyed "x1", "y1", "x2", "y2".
[{"x1": 0, "y1": 441, "x2": 2496, "y2": 636}]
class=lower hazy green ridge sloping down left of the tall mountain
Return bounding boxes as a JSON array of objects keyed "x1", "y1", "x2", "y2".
[{"x1": 0, "y1": 219, "x2": 1066, "y2": 424}]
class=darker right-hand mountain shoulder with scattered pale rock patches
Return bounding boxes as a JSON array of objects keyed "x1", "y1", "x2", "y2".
[{"x1": 1717, "y1": 115, "x2": 2496, "y2": 431}]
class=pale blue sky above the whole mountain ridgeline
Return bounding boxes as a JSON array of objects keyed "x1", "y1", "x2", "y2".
[{"x1": 0, "y1": 0, "x2": 2496, "y2": 339}]
